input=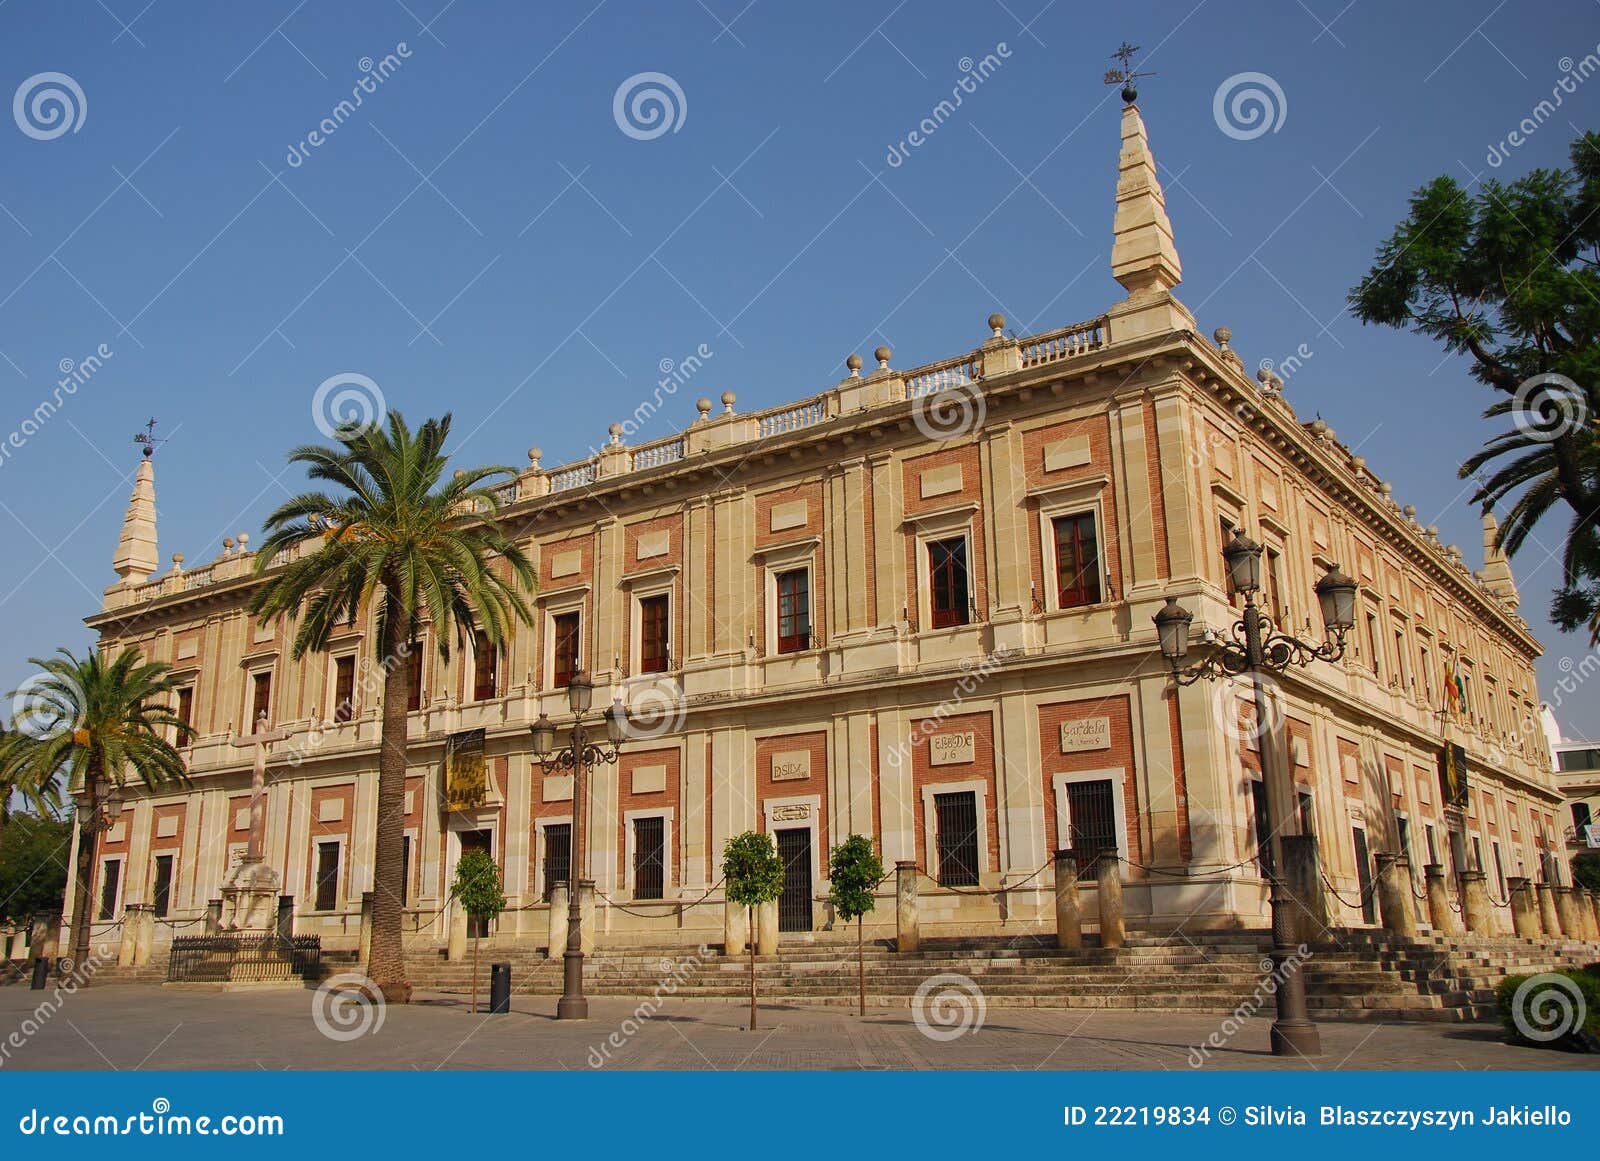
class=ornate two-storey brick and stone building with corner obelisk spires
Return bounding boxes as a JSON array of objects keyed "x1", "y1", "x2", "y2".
[{"x1": 69, "y1": 107, "x2": 1562, "y2": 945}]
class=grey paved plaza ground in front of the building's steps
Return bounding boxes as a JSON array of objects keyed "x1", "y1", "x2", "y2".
[{"x1": 0, "y1": 985, "x2": 1600, "y2": 1070}]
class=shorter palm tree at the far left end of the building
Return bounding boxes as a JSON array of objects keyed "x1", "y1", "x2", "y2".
[{"x1": 0, "y1": 646, "x2": 189, "y2": 985}]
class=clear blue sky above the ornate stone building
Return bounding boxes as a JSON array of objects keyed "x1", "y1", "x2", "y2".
[{"x1": 0, "y1": 0, "x2": 1600, "y2": 736}]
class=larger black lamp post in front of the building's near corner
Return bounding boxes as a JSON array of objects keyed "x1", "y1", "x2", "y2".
[{"x1": 1154, "y1": 529, "x2": 1355, "y2": 1055}]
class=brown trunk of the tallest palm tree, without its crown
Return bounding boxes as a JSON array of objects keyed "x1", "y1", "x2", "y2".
[{"x1": 368, "y1": 594, "x2": 411, "y2": 1004}]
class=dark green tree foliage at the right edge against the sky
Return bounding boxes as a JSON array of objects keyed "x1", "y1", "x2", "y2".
[{"x1": 1349, "y1": 133, "x2": 1600, "y2": 630}]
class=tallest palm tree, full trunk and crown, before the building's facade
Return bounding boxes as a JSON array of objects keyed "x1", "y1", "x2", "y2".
[{"x1": 250, "y1": 411, "x2": 536, "y2": 1003}]
